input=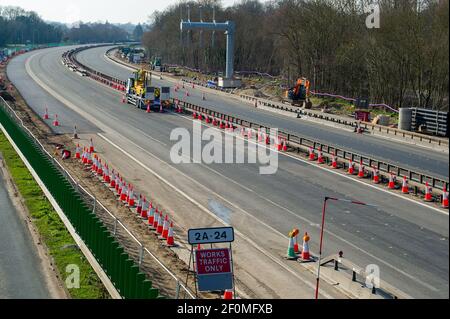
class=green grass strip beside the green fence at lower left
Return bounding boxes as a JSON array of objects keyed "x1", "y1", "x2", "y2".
[{"x1": 0, "y1": 132, "x2": 109, "y2": 299}]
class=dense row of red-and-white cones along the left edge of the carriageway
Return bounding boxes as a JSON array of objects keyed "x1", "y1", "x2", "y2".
[{"x1": 75, "y1": 139, "x2": 175, "y2": 247}]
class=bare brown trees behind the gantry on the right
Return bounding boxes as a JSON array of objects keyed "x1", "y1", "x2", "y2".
[{"x1": 143, "y1": 0, "x2": 449, "y2": 110}]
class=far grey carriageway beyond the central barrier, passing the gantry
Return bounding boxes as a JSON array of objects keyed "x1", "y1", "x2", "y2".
[{"x1": 77, "y1": 47, "x2": 449, "y2": 179}]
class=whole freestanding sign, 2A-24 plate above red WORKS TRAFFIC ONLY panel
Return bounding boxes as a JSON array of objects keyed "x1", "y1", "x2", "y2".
[{"x1": 186, "y1": 227, "x2": 236, "y2": 297}]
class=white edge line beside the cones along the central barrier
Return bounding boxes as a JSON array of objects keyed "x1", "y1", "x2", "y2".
[{"x1": 175, "y1": 114, "x2": 449, "y2": 216}]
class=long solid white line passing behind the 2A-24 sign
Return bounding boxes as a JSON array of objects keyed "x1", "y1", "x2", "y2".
[{"x1": 98, "y1": 133, "x2": 332, "y2": 299}]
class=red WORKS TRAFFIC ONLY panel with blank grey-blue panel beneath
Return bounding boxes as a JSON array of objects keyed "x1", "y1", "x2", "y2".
[{"x1": 195, "y1": 248, "x2": 233, "y2": 291}]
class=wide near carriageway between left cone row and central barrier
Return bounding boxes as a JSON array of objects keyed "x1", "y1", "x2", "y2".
[{"x1": 8, "y1": 48, "x2": 449, "y2": 298}]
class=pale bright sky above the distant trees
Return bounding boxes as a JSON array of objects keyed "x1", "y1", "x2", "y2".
[{"x1": 0, "y1": 0, "x2": 250, "y2": 24}]
